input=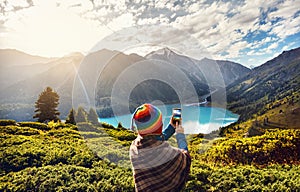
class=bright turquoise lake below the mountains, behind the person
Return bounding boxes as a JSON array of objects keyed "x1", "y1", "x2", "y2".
[{"x1": 99, "y1": 104, "x2": 239, "y2": 134}]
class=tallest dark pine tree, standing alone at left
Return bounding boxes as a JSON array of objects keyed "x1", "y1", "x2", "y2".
[{"x1": 33, "y1": 87, "x2": 60, "y2": 123}]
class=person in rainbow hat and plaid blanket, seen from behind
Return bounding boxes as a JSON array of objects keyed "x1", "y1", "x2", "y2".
[{"x1": 130, "y1": 104, "x2": 191, "y2": 192}]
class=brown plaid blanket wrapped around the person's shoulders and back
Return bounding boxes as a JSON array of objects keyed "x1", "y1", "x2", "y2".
[{"x1": 130, "y1": 136, "x2": 191, "y2": 192}]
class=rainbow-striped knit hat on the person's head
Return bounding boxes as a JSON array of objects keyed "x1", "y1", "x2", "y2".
[{"x1": 131, "y1": 103, "x2": 163, "y2": 136}]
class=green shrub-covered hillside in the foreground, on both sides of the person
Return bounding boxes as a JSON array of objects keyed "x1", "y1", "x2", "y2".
[{"x1": 0, "y1": 116, "x2": 300, "y2": 191}]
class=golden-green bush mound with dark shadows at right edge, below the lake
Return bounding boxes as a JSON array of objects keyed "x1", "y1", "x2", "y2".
[{"x1": 203, "y1": 130, "x2": 300, "y2": 165}]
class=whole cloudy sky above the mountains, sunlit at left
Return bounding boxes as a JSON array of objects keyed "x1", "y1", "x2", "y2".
[{"x1": 0, "y1": 0, "x2": 300, "y2": 67}]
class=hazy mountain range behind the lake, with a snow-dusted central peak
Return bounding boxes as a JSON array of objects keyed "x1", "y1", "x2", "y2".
[{"x1": 0, "y1": 48, "x2": 299, "y2": 121}]
